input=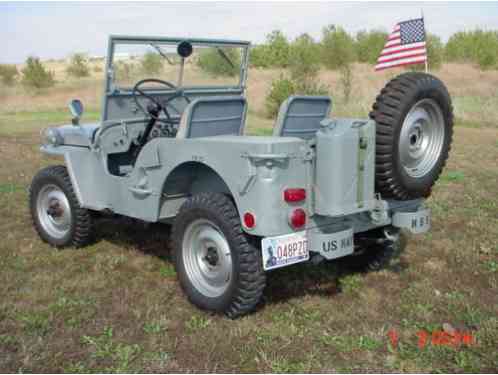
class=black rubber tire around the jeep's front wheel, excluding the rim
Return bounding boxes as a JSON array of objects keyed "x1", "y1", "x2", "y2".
[{"x1": 29, "y1": 165, "x2": 93, "y2": 247}]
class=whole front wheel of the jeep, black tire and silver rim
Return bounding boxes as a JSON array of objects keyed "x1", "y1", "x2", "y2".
[{"x1": 29, "y1": 165, "x2": 93, "y2": 247}]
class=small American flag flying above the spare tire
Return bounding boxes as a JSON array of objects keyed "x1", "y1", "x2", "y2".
[{"x1": 375, "y1": 18, "x2": 427, "y2": 70}]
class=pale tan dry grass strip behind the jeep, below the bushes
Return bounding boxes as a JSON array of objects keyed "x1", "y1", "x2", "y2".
[{"x1": 0, "y1": 62, "x2": 498, "y2": 128}]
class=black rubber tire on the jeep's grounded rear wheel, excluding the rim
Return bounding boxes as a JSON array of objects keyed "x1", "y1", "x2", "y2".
[{"x1": 171, "y1": 193, "x2": 266, "y2": 318}]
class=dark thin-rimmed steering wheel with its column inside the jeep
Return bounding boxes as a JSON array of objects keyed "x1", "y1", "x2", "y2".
[{"x1": 132, "y1": 78, "x2": 190, "y2": 147}]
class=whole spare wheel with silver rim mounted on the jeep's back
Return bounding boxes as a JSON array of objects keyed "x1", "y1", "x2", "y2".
[{"x1": 370, "y1": 72, "x2": 453, "y2": 200}]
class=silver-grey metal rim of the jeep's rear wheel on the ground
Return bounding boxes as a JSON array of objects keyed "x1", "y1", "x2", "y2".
[{"x1": 182, "y1": 219, "x2": 232, "y2": 298}]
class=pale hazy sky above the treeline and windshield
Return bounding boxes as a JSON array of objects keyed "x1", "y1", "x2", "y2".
[{"x1": 0, "y1": 1, "x2": 498, "y2": 63}]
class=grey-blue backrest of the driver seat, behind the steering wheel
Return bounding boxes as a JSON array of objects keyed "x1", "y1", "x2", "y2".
[{"x1": 176, "y1": 96, "x2": 247, "y2": 138}]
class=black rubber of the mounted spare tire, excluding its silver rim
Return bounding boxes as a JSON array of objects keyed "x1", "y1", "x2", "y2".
[{"x1": 370, "y1": 72, "x2": 453, "y2": 200}]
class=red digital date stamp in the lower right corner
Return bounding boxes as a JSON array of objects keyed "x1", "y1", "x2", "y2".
[{"x1": 387, "y1": 329, "x2": 475, "y2": 349}]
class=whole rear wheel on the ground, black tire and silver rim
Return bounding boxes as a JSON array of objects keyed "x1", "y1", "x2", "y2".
[{"x1": 172, "y1": 193, "x2": 265, "y2": 318}]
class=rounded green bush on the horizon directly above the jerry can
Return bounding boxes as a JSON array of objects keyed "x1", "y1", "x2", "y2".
[{"x1": 321, "y1": 25, "x2": 355, "y2": 70}]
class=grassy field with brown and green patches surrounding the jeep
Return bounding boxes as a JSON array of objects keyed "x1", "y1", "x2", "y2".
[{"x1": 0, "y1": 65, "x2": 498, "y2": 372}]
